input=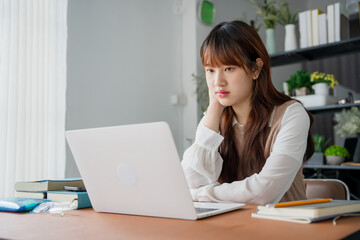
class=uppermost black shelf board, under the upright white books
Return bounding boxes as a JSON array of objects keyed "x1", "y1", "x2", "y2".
[{"x1": 270, "y1": 37, "x2": 360, "y2": 67}]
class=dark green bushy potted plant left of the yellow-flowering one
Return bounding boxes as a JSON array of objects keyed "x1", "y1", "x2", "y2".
[{"x1": 286, "y1": 70, "x2": 312, "y2": 96}]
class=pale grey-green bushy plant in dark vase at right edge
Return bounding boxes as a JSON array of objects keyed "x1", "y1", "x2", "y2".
[{"x1": 334, "y1": 107, "x2": 360, "y2": 162}]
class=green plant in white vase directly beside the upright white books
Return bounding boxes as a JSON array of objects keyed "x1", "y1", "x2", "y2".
[{"x1": 276, "y1": 0, "x2": 299, "y2": 51}]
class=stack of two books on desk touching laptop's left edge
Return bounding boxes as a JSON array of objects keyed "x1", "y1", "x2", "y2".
[{"x1": 15, "y1": 178, "x2": 91, "y2": 209}]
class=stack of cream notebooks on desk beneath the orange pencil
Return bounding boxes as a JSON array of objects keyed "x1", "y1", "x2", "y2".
[{"x1": 252, "y1": 200, "x2": 360, "y2": 223}]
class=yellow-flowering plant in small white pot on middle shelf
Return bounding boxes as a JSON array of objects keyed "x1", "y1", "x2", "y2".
[{"x1": 310, "y1": 71, "x2": 339, "y2": 95}]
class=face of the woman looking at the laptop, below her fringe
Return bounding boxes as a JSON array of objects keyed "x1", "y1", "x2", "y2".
[{"x1": 205, "y1": 65, "x2": 254, "y2": 108}]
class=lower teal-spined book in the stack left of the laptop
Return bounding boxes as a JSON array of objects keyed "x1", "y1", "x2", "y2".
[{"x1": 47, "y1": 191, "x2": 91, "y2": 209}]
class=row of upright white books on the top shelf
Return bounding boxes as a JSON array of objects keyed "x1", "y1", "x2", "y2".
[{"x1": 299, "y1": 2, "x2": 349, "y2": 48}]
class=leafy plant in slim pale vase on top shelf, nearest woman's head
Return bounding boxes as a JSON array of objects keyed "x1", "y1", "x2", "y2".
[{"x1": 249, "y1": 0, "x2": 278, "y2": 54}]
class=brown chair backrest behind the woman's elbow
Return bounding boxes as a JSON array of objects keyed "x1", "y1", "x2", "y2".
[{"x1": 304, "y1": 179, "x2": 350, "y2": 200}]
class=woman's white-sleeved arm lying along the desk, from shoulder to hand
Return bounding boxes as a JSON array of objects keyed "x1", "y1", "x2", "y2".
[{"x1": 191, "y1": 103, "x2": 310, "y2": 205}]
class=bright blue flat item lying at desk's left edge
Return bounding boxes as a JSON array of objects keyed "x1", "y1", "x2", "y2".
[{"x1": 0, "y1": 197, "x2": 48, "y2": 212}]
